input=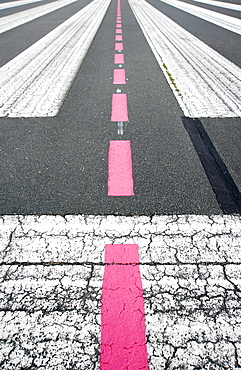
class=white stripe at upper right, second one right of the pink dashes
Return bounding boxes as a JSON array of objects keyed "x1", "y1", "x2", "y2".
[{"x1": 158, "y1": 0, "x2": 241, "y2": 35}]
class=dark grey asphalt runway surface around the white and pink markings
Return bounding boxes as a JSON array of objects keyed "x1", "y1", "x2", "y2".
[{"x1": 0, "y1": 0, "x2": 241, "y2": 215}]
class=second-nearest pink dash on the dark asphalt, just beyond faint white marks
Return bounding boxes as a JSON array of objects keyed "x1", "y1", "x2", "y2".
[{"x1": 111, "y1": 94, "x2": 129, "y2": 122}]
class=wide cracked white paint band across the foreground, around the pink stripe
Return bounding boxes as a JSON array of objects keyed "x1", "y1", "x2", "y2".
[{"x1": 0, "y1": 215, "x2": 241, "y2": 370}]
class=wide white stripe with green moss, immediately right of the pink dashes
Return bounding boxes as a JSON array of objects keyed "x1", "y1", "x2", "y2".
[{"x1": 129, "y1": 0, "x2": 241, "y2": 117}]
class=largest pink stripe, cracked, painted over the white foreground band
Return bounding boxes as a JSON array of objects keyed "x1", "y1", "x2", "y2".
[{"x1": 100, "y1": 244, "x2": 148, "y2": 370}]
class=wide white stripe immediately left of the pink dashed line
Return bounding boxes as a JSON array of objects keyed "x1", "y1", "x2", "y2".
[{"x1": 0, "y1": 0, "x2": 110, "y2": 117}]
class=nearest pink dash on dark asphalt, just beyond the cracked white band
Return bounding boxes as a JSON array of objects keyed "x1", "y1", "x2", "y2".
[{"x1": 108, "y1": 140, "x2": 134, "y2": 196}]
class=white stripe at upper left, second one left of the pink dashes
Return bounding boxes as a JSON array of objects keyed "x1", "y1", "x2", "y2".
[{"x1": 0, "y1": 0, "x2": 77, "y2": 33}]
